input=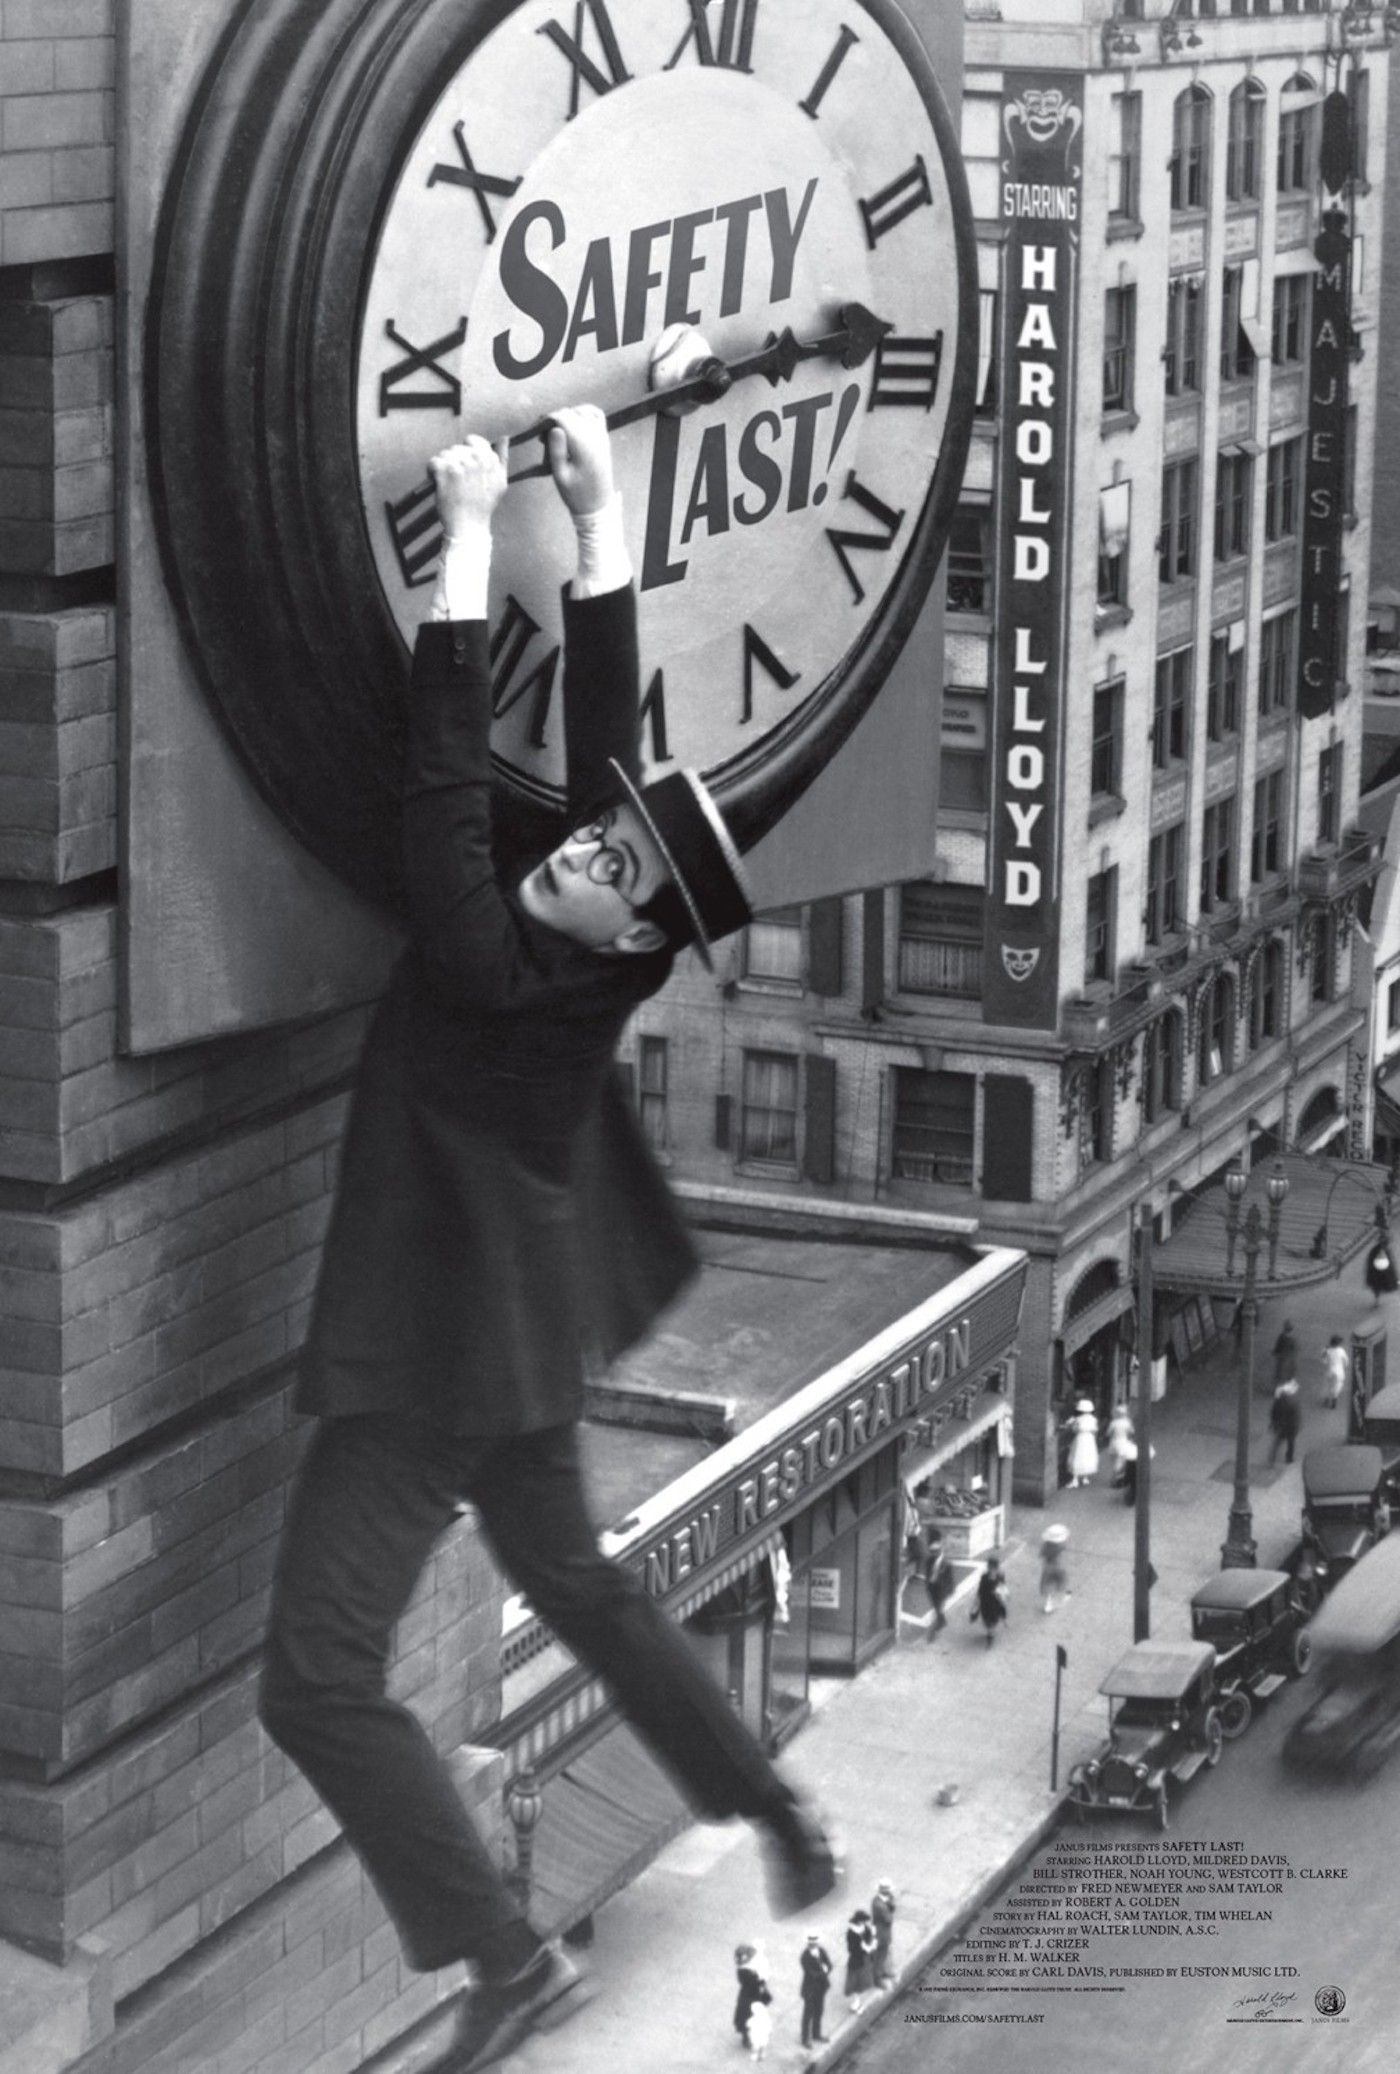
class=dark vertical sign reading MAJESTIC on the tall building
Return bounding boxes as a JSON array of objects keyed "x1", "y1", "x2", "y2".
[{"x1": 1298, "y1": 209, "x2": 1352, "y2": 720}]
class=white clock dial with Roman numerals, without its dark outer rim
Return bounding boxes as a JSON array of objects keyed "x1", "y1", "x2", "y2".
[{"x1": 357, "y1": 0, "x2": 974, "y2": 790}]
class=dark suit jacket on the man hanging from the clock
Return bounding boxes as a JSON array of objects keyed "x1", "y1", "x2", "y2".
[{"x1": 297, "y1": 589, "x2": 695, "y2": 1435}]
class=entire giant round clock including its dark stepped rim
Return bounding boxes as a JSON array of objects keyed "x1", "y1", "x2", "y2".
[{"x1": 147, "y1": 0, "x2": 977, "y2": 896}]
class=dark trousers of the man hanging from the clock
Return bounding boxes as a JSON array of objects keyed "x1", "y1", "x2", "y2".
[{"x1": 261, "y1": 1414, "x2": 784, "y2": 1970}]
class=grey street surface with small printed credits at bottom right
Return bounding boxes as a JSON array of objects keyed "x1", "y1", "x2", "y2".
[{"x1": 846, "y1": 1676, "x2": 1400, "y2": 2074}]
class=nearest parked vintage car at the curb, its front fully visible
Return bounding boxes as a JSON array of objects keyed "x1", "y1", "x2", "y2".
[{"x1": 1070, "y1": 1643, "x2": 1226, "y2": 1829}]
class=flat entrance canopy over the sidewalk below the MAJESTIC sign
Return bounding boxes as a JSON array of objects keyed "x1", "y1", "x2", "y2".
[{"x1": 1151, "y1": 1153, "x2": 1390, "y2": 1296}]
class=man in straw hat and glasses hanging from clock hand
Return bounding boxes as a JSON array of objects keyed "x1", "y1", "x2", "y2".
[{"x1": 261, "y1": 407, "x2": 838, "y2": 2074}]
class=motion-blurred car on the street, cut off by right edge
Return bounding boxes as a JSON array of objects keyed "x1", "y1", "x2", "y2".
[{"x1": 1284, "y1": 1535, "x2": 1400, "y2": 1777}]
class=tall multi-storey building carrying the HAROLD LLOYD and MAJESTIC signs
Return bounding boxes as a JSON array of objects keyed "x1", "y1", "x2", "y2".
[{"x1": 635, "y1": 0, "x2": 1390, "y2": 1500}]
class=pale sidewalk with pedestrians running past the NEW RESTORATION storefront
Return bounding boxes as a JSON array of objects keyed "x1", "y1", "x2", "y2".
[{"x1": 385, "y1": 1263, "x2": 1400, "y2": 2074}]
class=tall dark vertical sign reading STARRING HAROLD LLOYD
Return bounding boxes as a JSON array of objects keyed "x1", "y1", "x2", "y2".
[{"x1": 983, "y1": 73, "x2": 1083, "y2": 1029}]
